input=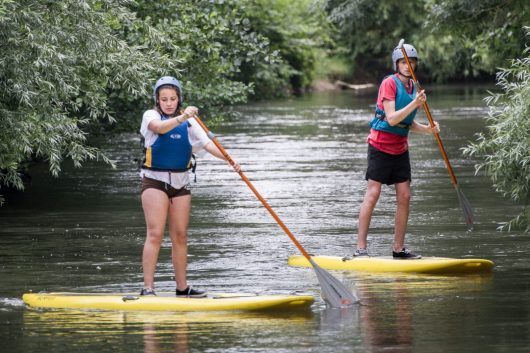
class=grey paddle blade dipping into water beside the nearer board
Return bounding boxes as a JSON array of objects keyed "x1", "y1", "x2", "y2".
[{"x1": 309, "y1": 259, "x2": 359, "y2": 308}]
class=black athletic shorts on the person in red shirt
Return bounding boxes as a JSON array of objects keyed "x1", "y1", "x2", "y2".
[{"x1": 366, "y1": 144, "x2": 411, "y2": 185}]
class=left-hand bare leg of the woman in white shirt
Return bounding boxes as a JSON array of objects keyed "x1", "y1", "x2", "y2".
[{"x1": 142, "y1": 189, "x2": 169, "y2": 289}]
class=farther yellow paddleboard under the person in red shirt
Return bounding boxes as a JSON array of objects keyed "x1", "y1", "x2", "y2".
[{"x1": 289, "y1": 256, "x2": 494, "y2": 274}]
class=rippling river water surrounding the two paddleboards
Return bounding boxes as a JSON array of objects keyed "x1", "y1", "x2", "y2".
[{"x1": 0, "y1": 87, "x2": 530, "y2": 353}]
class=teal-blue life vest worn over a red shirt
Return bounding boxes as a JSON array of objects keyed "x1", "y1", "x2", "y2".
[{"x1": 370, "y1": 75, "x2": 417, "y2": 136}]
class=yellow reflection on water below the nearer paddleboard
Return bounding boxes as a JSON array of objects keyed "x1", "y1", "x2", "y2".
[{"x1": 24, "y1": 310, "x2": 313, "y2": 353}]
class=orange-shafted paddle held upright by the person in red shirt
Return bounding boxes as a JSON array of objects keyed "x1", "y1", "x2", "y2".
[{"x1": 397, "y1": 39, "x2": 473, "y2": 230}]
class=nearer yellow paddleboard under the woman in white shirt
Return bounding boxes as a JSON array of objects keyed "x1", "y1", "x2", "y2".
[{"x1": 22, "y1": 292, "x2": 315, "y2": 311}]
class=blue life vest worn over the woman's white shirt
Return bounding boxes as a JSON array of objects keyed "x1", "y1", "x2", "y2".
[{"x1": 142, "y1": 115, "x2": 193, "y2": 172}]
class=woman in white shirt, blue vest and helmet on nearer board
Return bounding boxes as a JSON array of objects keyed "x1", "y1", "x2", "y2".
[{"x1": 140, "y1": 76, "x2": 240, "y2": 298}]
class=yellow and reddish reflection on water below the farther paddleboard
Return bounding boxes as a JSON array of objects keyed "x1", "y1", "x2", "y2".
[{"x1": 358, "y1": 275, "x2": 491, "y2": 353}]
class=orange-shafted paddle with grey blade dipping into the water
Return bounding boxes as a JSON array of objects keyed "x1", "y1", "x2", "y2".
[{"x1": 195, "y1": 116, "x2": 359, "y2": 308}]
